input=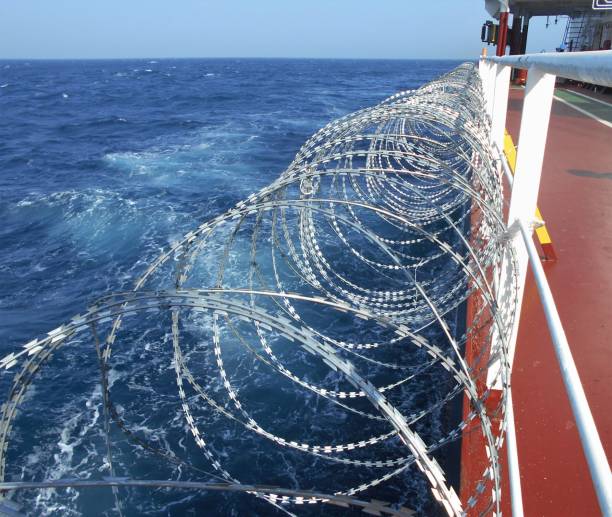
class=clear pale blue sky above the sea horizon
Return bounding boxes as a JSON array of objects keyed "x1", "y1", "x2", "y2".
[{"x1": 0, "y1": 0, "x2": 565, "y2": 59}]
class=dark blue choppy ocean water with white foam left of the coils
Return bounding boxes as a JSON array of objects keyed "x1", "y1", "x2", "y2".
[{"x1": 0, "y1": 59, "x2": 458, "y2": 515}]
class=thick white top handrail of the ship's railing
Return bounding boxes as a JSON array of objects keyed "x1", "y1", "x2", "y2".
[{"x1": 484, "y1": 50, "x2": 612, "y2": 86}]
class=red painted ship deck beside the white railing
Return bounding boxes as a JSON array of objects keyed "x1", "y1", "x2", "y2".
[{"x1": 461, "y1": 89, "x2": 612, "y2": 517}]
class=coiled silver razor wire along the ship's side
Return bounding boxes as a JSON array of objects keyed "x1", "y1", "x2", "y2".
[{"x1": 0, "y1": 64, "x2": 516, "y2": 516}]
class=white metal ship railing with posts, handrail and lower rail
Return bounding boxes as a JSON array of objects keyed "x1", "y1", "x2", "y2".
[{"x1": 479, "y1": 51, "x2": 612, "y2": 517}]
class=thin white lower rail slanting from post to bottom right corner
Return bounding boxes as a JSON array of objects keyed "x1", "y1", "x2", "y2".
[{"x1": 518, "y1": 220, "x2": 612, "y2": 517}]
